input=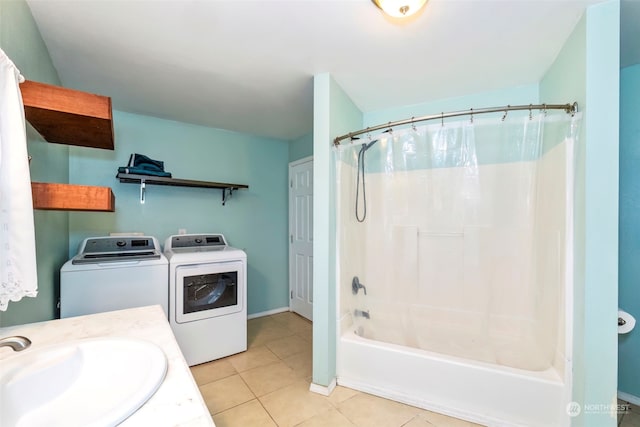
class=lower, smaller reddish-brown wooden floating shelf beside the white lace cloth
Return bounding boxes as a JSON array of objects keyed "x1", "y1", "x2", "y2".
[{"x1": 31, "y1": 182, "x2": 116, "y2": 212}]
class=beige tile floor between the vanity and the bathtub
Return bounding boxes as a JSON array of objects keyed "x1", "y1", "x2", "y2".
[{"x1": 191, "y1": 313, "x2": 484, "y2": 427}]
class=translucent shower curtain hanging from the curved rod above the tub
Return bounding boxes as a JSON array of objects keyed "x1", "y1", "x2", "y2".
[{"x1": 336, "y1": 113, "x2": 580, "y2": 371}]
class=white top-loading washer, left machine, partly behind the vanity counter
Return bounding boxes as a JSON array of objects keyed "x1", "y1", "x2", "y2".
[{"x1": 60, "y1": 236, "x2": 169, "y2": 318}]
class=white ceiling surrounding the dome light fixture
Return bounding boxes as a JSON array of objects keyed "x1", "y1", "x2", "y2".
[{"x1": 26, "y1": 0, "x2": 640, "y2": 139}]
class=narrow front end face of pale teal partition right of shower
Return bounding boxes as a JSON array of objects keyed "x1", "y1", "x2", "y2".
[{"x1": 574, "y1": 0, "x2": 620, "y2": 427}]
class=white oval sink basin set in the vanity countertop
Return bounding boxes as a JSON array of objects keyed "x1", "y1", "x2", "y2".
[{"x1": 0, "y1": 337, "x2": 167, "y2": 427}]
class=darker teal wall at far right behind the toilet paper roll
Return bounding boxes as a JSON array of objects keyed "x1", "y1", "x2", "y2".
[{"x1": 618, "y1": 64, "x2": 640, "y2": 399}]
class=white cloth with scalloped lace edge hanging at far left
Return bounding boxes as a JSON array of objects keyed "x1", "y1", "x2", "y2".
[{"x1": 0, "y1": 49, "x2": 38, "y2": 311}]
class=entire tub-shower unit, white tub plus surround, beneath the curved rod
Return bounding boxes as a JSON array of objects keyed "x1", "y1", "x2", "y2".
[{"x1": 336, "y1": 114, "x2": 579, "y2": 427}]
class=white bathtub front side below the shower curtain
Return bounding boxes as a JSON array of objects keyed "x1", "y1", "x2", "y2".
[{"x1": 337, "y1": 330, "x2": 570, "y2": 427}]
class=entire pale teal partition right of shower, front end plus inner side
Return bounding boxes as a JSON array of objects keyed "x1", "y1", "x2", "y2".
[{"x1": 540, "y1": 0, "x2": 620, "y2": 427}]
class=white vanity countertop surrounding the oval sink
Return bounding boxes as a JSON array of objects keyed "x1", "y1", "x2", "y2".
[{"x1": 0, "y1": 305, "x2": 215, "y2": 427}]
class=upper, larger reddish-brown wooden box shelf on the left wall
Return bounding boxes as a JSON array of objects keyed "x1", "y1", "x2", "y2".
[{"x1": 20, "y1": 80, "x2": 114, "y2": 150}]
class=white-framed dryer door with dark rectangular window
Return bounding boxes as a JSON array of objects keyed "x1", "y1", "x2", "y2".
[{"x1": 175, "y1": 261, "x2": 245, "y2": 323}]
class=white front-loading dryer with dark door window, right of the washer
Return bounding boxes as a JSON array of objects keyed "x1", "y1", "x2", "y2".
[{"x1": 164, "y1": 234, "x2": 247, "y2": 366}]
